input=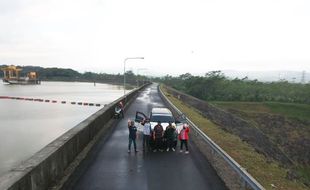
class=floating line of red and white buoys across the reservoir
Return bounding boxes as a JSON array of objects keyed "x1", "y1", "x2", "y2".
[{"x1": 0, "y1": 96, "x2": 104, "y2": 107}]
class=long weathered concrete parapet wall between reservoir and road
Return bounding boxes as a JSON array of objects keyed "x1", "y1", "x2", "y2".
[{"x1": 0, "y1": 84, "x2": 148, "y2": 190}]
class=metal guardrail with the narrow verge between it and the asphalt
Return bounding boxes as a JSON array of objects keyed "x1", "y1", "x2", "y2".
[{"x1": 159, "y1": 85, "x2": 264, "y2": 190}]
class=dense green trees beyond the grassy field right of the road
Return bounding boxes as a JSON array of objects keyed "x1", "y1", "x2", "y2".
[{"x1": 157, "y1": 71, "x2": 310, "y2": 104}]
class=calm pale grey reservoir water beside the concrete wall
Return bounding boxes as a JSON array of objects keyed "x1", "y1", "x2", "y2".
[{"x1": 0, "y1": 82, "x2": 123, "y2": 175}]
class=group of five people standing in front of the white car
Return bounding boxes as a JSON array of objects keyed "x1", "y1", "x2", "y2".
[{"x1": 128, "y1": 119, "x2": 189, "y2": 154}]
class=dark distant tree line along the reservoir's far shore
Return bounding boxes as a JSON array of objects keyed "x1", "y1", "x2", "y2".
[{"x1": 0, "y1": 65, "x2": 148, "y2": 85}]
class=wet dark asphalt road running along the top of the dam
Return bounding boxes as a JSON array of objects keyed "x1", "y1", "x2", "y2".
[{"x1": 67, "y1": 84, "x2": 227, "y2": 190}]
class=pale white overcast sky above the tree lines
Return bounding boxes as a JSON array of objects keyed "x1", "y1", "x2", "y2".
[{"x1": 0, "y1": 0, "x2": 310, "y2": 75}]
